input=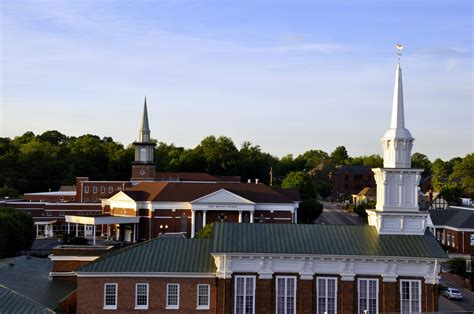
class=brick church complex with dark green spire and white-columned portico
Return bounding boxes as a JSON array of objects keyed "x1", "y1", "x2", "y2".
[{"x1": 2, "y1": 99, "x2": 300, "y2": 238}]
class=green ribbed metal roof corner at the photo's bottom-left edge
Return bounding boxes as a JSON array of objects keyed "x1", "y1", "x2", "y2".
[{"x1": 0, "y1": 285, "x2": 54, "y2": 313}]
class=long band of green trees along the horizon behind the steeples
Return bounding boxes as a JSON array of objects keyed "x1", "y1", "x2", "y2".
[{"x1": 0, "y1": 130, "x2": 468, "y2": 204}]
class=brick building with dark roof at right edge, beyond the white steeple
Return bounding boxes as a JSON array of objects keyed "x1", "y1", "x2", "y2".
[{"x1": 428, "y1": 206, "x2": 474, "y2": 256}]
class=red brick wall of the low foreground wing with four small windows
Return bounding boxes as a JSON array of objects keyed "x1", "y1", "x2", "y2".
[{"x1": 77, "y1": 277, "x2": 217, "y2": 313}]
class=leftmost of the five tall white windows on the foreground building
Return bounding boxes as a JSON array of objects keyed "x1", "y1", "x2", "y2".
[{"x1": 234, "y1": 276, "x2": 255, "y2": 314}]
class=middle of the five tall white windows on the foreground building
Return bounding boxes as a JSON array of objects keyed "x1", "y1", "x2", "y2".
[{"x1": 316, "y1": 277, "x2": 337, "y2": 314}]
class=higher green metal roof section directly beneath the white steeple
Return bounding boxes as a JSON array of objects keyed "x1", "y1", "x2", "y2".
[{"x1": 211, "y1": 223, "x2": 448, "y2": 258}]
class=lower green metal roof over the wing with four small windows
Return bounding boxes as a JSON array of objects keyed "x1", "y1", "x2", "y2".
[{"x1": 77, "y1": 238, "x2": 216, "y2": 273}]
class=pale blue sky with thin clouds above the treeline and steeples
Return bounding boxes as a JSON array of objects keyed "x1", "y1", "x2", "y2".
[{"x1": 0, "y1": 0, "x2": 474, "y2": 160}]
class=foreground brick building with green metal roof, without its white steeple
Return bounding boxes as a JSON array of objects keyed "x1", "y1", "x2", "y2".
[{"x1": 76, "y1": 223, "x2": 447, "y2": 313}]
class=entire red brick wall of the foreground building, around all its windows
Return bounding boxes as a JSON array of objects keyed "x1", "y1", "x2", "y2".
[{"x1": 77, "y1": 274, "x2": 438, "y2": 314}]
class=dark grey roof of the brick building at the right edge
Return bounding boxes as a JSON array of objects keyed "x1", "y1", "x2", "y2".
[{"x1": 429, "y1": 207, "x2": 474, "y2": 229}]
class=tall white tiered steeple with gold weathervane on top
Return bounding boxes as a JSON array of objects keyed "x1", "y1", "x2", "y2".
[{"x1": 367, "y1": 45, "x2": 428, "y2": 235}]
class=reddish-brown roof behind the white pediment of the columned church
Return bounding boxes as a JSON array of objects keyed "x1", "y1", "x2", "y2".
[{"x1": 123, "y1": 182, "x2": 292, "y2": 203}]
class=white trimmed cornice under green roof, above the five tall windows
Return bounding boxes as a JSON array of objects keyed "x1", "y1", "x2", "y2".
[{"x1": 213, "y1": 254, "x2": 444, "y2": 283}]
